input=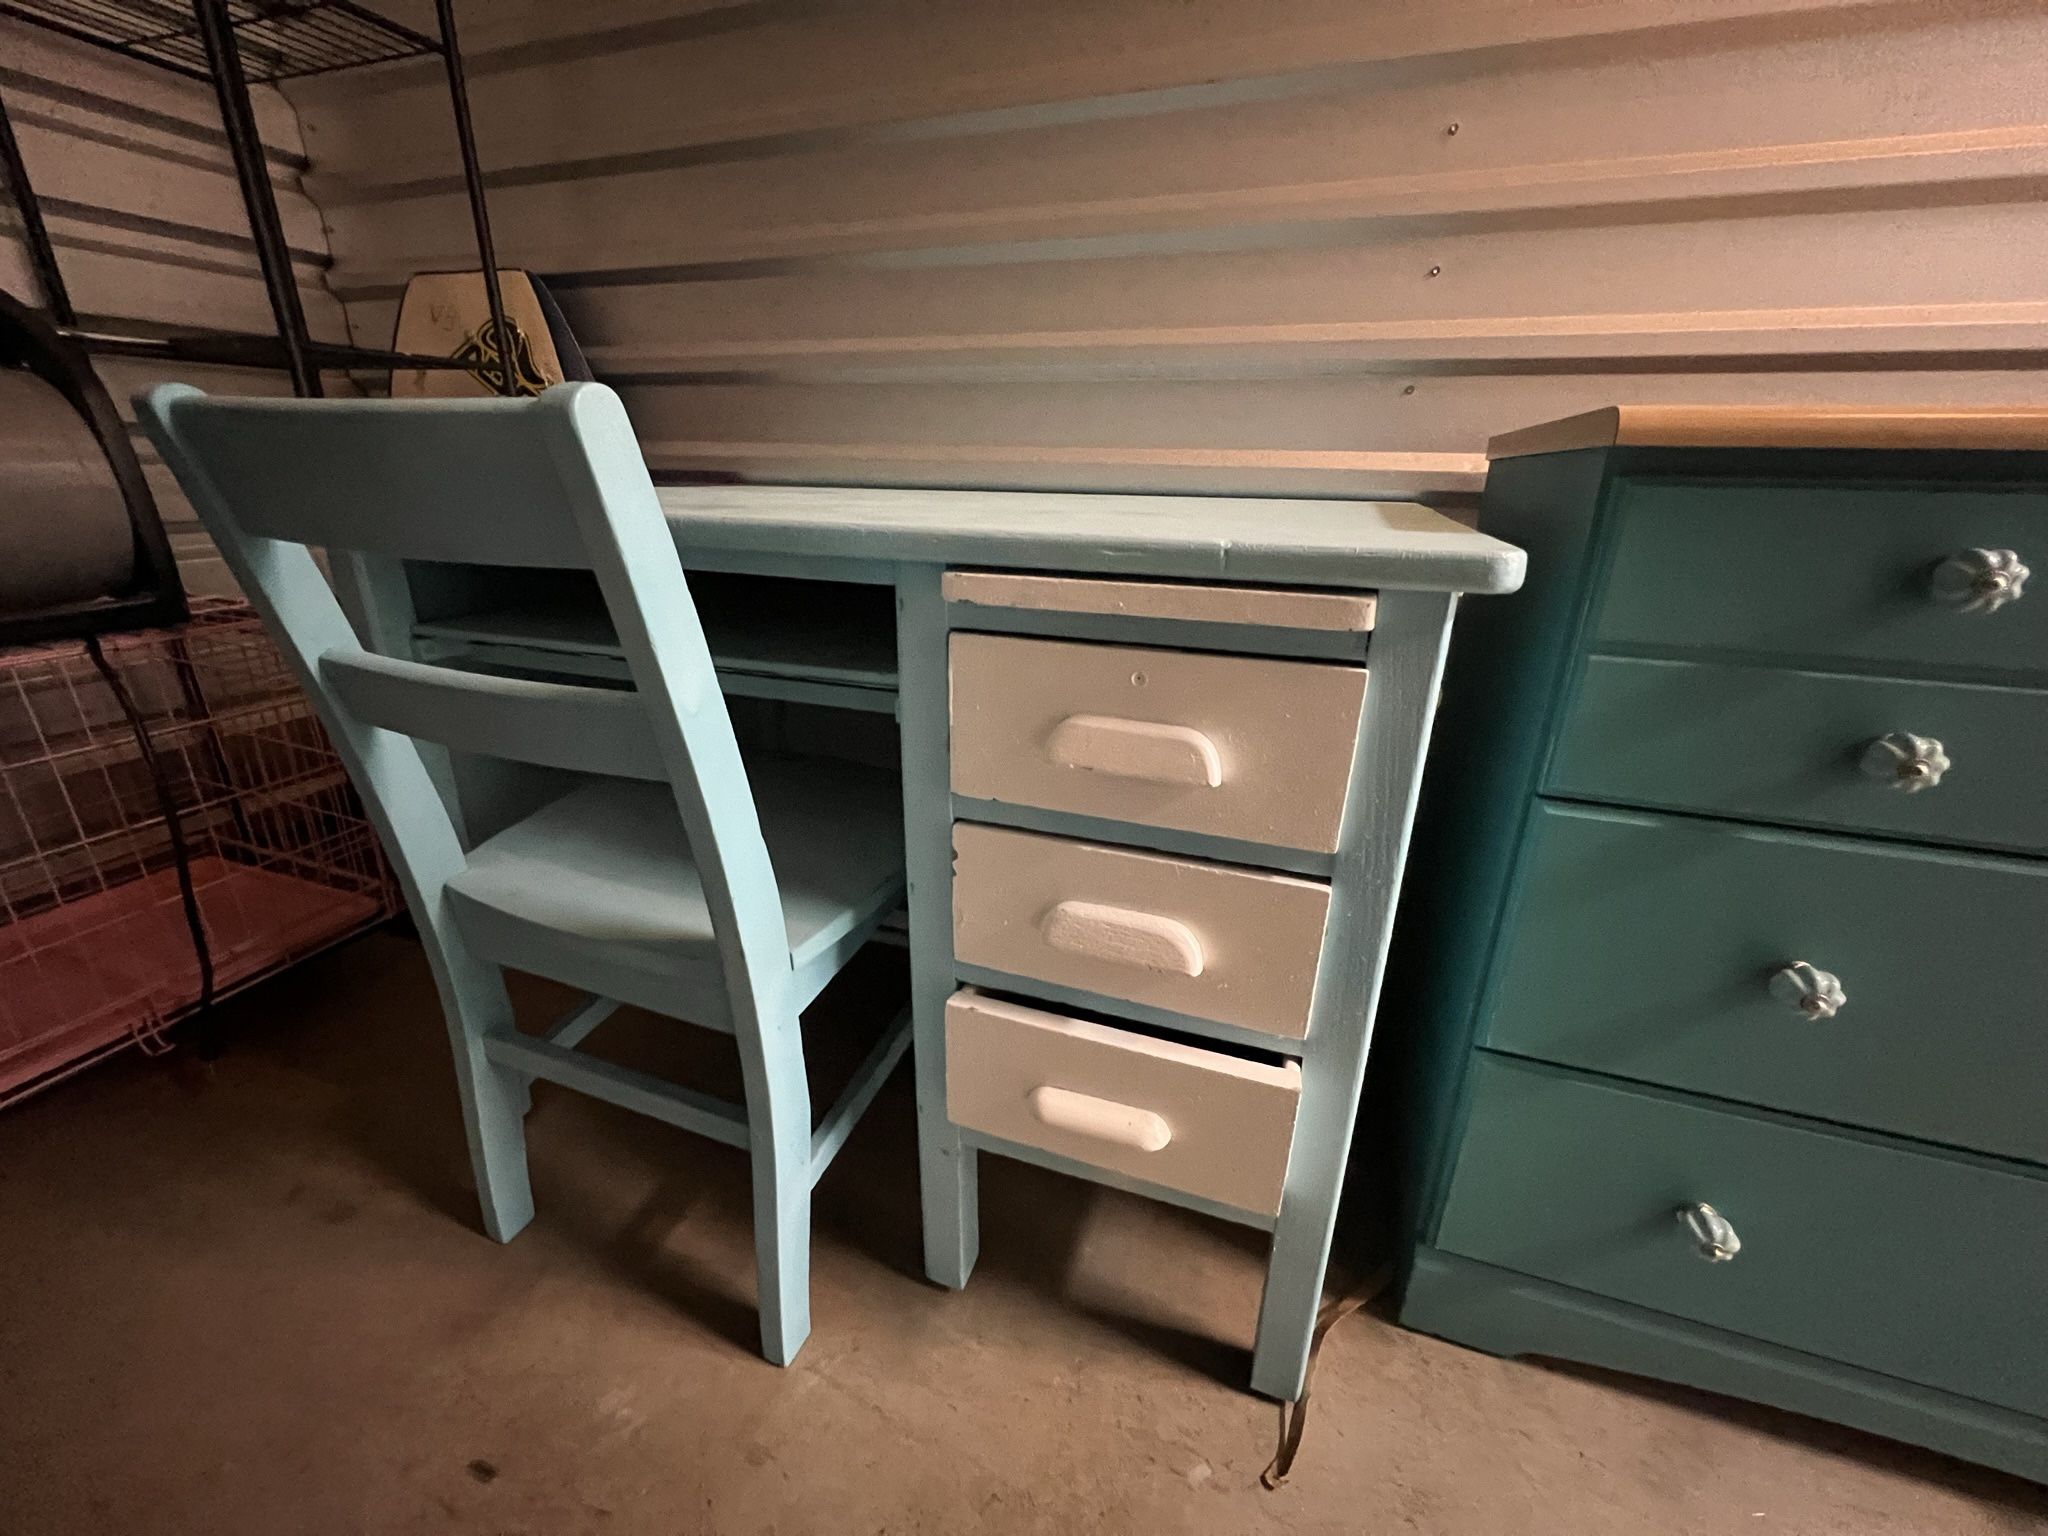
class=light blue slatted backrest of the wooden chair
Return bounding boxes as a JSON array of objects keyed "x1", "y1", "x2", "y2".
[{"x1": 137, "y1": 383, "x2": 788, "y2": 1012}]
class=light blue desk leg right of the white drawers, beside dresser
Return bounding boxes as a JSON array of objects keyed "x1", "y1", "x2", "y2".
[{"x1": 1251, "y1": 592, "x2": 1456, "y2": 1401}]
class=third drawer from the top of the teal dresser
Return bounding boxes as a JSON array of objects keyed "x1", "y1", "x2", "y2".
[{"x1": 1487, "y1": 805, "x2": 2048, "y2": 1163}]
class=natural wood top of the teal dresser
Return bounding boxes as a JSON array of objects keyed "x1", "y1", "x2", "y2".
[{"x1": 1487, "y1": 406, "x2": 2048, "y2": 459}]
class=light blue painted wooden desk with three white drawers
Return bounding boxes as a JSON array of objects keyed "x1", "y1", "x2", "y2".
[{"x1": 416, "y1": 487, "x2": 1524, "y2": 1399}]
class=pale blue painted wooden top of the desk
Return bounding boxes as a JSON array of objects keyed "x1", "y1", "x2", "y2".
[{"x1": 659, "y1": 485, "x2": 1524, "y2": 592}]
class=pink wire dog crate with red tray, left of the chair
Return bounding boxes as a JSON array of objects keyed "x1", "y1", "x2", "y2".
[{"x1": 0, "y1": 598, "x2": 397, "y2": 1104}]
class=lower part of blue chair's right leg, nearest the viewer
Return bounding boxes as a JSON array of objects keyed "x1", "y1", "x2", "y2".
[{"x1": 739, "y1": 1014, "x2": 811, "y2": 1366}]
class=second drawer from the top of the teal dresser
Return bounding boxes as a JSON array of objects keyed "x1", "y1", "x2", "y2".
[{"x1": 1546, "y1": 655, "x2": 2048, "y2": 852}]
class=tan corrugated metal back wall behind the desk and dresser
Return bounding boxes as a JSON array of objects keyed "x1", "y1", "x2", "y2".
[{"x1": 291, "y1": 0, "x2": 2048, "y2": 512}]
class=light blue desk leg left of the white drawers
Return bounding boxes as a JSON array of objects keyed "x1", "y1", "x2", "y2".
[{"x1": 897, "y1": 565, "x2": 981, "y2": 1290}]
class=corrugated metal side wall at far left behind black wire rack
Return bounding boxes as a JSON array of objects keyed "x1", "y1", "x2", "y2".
[{"x1": 0, "y1": 20, "x2": 346, "y2": 592}]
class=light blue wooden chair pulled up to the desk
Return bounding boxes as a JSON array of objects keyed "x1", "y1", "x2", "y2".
[{"x1": 137, "y1": 385, "x2": 909, "y2": 1364}]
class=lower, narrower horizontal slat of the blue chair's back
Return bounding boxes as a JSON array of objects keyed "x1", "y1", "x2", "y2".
[{"x1": 319, "y1": 651, "x2": 668, "y2": 782}]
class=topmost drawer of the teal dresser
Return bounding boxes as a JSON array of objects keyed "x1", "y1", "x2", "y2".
[{"x1": 1593, "y1": 481, "x2": 2048, "y2": 676}]
